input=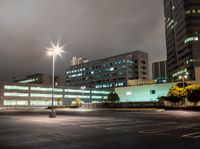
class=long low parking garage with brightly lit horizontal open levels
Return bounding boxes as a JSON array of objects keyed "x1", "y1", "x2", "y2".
[{"x1": 0, "y1": 83, "x2": 110, "y2": 107}]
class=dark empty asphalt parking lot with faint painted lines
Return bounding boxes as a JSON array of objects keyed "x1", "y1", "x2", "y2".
[{"x1": 0, "y1": 110, "x2": 200, "y2": 149}]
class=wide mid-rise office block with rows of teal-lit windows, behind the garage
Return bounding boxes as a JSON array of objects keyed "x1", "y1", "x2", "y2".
[{"x1": 66, "y1": 51, "x2": 148, "y2": 88}]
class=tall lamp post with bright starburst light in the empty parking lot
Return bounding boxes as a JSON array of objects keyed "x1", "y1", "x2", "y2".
[{"x1": 47, "y1": 42, "x2": 64, "y2": 118}]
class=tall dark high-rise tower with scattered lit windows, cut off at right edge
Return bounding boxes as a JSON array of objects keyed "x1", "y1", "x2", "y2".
[{"x1": 164, "y1": 0, "x2": 200, "y2": 81}]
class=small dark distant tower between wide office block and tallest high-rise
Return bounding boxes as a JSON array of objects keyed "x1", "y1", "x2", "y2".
[{"x1": 152, "y1": 61, "x2": 167, "y2": 83}]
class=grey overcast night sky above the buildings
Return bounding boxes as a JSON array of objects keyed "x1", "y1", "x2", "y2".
[{"x1": 0, "y1": 0, "x2": 166, "y2": 81}]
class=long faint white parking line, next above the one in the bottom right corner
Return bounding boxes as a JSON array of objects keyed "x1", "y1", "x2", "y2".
[{"x1": 138, "y1": 123, "x2": 200, "y2": 134}]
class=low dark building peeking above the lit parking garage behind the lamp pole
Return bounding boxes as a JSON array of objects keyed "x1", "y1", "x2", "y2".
[{"x1": 13, "y1": 73, "x2": 65, "y2": 85}]
